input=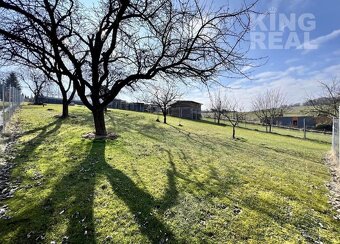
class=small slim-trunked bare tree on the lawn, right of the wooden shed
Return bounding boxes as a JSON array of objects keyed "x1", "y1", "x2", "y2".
[{"x1": 223, "y1": 97, "x2": 245, "y2": 139}]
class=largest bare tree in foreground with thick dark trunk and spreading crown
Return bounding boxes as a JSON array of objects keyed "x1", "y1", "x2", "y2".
[{"x1": 0, "y1": 0, "x2": 256, "y2": 135}]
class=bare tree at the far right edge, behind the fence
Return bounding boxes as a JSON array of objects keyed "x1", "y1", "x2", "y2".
[{"x1": 305, "y1": 79, "x2": 340, "y2": 118}]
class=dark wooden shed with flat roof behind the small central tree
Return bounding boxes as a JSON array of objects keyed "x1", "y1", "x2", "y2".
[{"x1": 169, "y1": 100, "x2": 202, "y2": 120}]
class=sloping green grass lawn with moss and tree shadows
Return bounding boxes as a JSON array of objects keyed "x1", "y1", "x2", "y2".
[{"x1": 0, "y1": 105, "x2": 340, "y2": 243}]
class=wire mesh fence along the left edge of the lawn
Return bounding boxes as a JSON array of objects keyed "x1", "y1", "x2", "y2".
[{"x1": 0, "y1": 84, "x2": 23, "y2": 132}]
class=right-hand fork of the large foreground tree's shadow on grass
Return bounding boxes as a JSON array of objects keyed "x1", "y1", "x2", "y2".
[{"x1": 98, "y1": 141, "x2": 178, "y2": 243}]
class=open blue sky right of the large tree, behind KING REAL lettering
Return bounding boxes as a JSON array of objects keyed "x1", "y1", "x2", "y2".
[{"x1": 3, "y1": 0, "x2": 340, "y2": 110}]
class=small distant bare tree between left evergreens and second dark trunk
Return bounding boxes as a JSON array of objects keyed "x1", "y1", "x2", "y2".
[{"x1": 21, "y1": 69, "x2": 50, "y2": 105}]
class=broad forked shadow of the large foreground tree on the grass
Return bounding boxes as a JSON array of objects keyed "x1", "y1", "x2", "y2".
[{"x1": 0, "y1": 137, "x2": 178, "y2": 243}]
